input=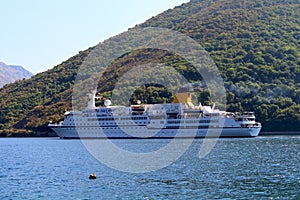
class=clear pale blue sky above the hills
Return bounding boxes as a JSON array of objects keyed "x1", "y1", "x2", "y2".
[{"x1": 0, "y1": 0, "x2": 189, "y2": 74}]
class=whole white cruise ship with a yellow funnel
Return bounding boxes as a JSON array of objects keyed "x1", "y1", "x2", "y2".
[{"x1": 48, "y1": 91, "x2": 262, "y2": 139}]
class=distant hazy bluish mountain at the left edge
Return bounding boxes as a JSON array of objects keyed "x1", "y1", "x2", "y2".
[{"x1": 0, "y1": 62, "x2": 33, "y2": 88}]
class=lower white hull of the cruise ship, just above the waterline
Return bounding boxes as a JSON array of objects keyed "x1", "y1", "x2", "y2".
[{"x1": 51, "y1": 126, "x2": 261, "y2": 139}]
